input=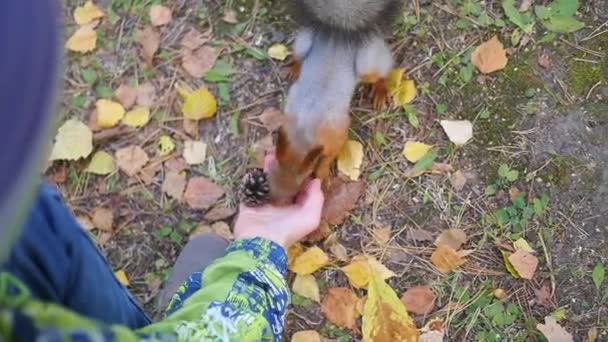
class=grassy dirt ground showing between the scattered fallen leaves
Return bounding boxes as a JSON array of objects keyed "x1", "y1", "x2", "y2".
[{"x1": 53, "y1": 0, "x2": 608, "y2": 341}]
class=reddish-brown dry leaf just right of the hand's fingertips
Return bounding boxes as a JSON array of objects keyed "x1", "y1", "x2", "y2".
[{"x1": 321, "y1": 177, "x2": 365, "y2": 225}]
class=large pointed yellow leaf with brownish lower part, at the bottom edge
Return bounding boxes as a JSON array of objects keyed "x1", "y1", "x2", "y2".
[{"x1": 363, "y1": 272, "x2": 418, "y2": 342}]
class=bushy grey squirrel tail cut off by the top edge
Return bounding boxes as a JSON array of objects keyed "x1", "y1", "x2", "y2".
[{"x1": 290, "y1": 0, "x2": 403, "y2": 41}]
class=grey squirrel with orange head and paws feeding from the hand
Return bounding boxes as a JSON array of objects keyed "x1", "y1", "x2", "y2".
[{"x1": 268, "y1": 0, "x2": 399, "y2": 204}]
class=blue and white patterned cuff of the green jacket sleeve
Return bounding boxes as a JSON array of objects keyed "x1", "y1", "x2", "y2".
[{"x1": 226, "y1": 238, "x2": 287, "y2": 277}]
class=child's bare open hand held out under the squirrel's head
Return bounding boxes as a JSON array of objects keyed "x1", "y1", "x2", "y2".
[{"x1": 234, "y1": 156, "x2": 324, "y2": 249}]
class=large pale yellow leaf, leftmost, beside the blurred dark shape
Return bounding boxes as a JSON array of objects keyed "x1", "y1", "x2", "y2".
[{"x1": 50, "y1": 119, "x2": 93, "y2": 160}]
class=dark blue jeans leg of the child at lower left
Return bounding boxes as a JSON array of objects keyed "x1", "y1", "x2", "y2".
[{"x1": 0, "y1": 185, "x2": 151, "y2": 329}]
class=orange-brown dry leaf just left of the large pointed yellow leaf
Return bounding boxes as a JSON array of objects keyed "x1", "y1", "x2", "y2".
[{"x1": 321, "y1": 287, "x2": 359, "y2": 331}]
